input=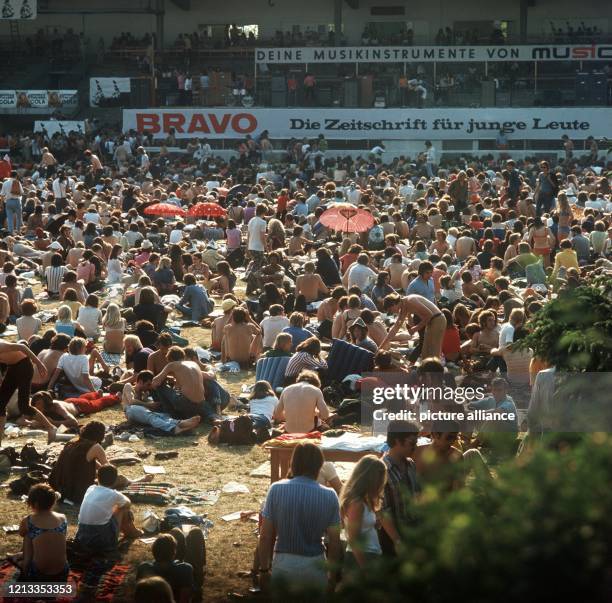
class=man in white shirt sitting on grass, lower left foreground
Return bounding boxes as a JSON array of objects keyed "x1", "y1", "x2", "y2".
[{"x1": 75, "y1": 465, "x2": 142, "y2": 553}]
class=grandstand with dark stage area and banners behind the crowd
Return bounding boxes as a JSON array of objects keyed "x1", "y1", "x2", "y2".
[{"x1": 0, "y1": 0, "x2": 612, "y2": 160}]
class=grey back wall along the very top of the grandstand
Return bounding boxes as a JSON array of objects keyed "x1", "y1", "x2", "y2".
[{"x1": 5, "y1": 0, "x2": 612, "y2": 45}]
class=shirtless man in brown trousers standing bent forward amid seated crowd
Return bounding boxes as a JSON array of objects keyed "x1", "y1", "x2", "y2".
[{"x1": 379, "y1": 293, "x2": 446, "y2": 358}]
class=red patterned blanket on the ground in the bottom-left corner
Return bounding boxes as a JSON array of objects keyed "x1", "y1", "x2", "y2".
[{"x1": 0, "y1": 559, "x2": 131, "y2": 603}]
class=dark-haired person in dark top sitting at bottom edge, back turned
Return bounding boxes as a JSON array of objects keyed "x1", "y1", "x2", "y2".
[{"x1": 136, "y1": 534, "x2": 194, "y2": 603}]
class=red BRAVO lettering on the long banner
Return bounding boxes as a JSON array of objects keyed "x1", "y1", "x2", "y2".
[{"x1": 136, "y1": 113, "x2": 257, "y2": 134}]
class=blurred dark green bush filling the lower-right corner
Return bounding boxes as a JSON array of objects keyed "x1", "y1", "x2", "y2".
[{"x1": 337, "y1": 433, "x2": 612, "y2": 603}]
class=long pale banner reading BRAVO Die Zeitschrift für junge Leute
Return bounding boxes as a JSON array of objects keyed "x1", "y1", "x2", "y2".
[{"x1": 123, "y1": 107, "x2": 612, "y2": 140}]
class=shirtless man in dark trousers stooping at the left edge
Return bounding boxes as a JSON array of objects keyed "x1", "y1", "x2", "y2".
[{"x1": 0, "y1": 341, "x2": 57, "y2": 444}]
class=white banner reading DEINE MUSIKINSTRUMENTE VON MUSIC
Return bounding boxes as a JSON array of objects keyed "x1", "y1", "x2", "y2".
[{"x1": 255, "y1": 44, "x2": 612, "y2": 65}]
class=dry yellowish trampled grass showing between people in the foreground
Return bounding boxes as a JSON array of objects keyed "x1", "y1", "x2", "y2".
[{"x1": 0, "y1": 286, "x2": 269, "y2": 601}]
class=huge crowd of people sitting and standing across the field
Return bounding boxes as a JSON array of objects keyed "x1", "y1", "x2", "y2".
[{"x1": 0, "y1": 125, "x2": 612, "y2": 601}]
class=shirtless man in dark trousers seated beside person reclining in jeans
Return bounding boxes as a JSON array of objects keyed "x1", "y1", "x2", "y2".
[{"x1": 151, "y1": 346, "x2": 229, "y2": 420}]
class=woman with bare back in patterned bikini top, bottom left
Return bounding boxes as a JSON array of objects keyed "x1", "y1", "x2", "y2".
[{"x1": 11, "y1": 484, "x2": 70, "y2": 582}]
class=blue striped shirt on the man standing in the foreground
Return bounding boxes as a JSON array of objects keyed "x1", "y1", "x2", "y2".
[{"x1": 262, "y1": 476, "x2": 340, "y2": 557}]
